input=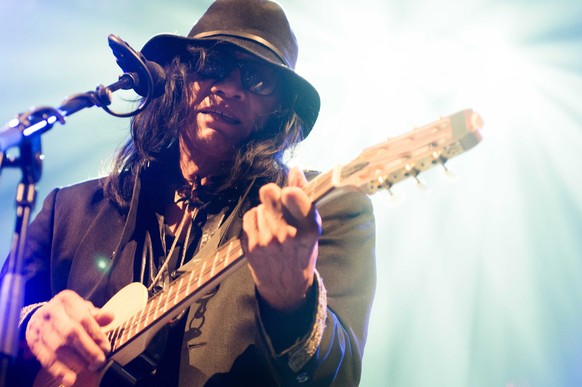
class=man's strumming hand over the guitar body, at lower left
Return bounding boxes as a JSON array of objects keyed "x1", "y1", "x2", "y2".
[{"x1": 26, "y1": 290, "x2": 113, "y2": 386}]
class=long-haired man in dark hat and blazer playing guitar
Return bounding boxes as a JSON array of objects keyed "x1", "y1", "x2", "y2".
[{"x1": 5, "y1": 0, "x2": 375, "y2": 386}]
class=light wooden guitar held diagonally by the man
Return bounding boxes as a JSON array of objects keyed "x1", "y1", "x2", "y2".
[{"x1": 34, "y1": 110, "x2": 482, "y2": 387}]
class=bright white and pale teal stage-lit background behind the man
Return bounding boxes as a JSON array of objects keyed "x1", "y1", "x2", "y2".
[{"x1": 0, "y1": 0, "x2": 582, "y2": 387}]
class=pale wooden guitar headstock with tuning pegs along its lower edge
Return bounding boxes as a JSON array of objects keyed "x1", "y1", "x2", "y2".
[{"x1": 331, "y1": 109, "x2": 483, "y2": 194}]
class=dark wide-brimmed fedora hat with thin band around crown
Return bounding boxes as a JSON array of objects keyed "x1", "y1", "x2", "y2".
[{"x1": 141, "y1": 0, "x2": 320, "y2": 138}]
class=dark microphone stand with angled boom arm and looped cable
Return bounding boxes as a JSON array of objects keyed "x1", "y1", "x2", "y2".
[{"x1": 0, "y1": 36, "x2": 161, "y2": 387}]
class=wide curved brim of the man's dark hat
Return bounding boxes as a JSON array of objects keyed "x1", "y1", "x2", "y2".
[{"x1": 141, "y1": 34, "x2": 320, "y2": 138}]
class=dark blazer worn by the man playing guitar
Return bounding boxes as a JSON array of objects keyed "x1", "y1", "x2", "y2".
[{"x1": 6, "y1": 180, "x2": 376, "y2": 386}]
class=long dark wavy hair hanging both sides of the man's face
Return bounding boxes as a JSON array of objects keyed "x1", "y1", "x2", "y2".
[{"x1": 103, "y1": 47, "x2": 304, "y2": 212}]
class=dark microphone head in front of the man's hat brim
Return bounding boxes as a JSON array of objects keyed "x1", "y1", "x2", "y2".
[{"x1": 107, "y1": 34, "x2": 166, "y2": 98}]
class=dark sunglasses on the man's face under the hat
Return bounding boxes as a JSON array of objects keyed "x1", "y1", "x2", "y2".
[{"x1": 197, "y1": 51, "x2": 280, "y2": 96}]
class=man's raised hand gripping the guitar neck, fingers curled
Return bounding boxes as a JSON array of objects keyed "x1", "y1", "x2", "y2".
[{"x1": 243, "y1": 168, "x2": 321, "y2": 312}]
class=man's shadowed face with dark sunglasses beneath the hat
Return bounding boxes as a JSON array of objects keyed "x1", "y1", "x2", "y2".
[{"x1": 181, "y1": 52, "x2": 280, "y2": 162}]
